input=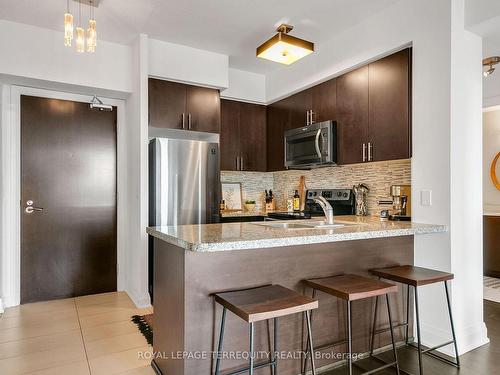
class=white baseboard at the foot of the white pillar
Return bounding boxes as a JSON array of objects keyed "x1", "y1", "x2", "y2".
[{"x1": 421, "y1": 322, "x2": 490, "y2": 357}]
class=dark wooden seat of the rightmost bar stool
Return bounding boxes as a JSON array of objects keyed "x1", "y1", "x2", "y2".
[{"x1": 370, "y1": 266, "x2": 453, "y2": 287}]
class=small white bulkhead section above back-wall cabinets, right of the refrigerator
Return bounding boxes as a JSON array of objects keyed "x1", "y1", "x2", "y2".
[{"x1": 220, "y1": 68, "x2": 266, "y2": 104}]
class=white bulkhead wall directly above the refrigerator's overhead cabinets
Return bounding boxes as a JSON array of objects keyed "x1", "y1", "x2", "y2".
[{"x1": 148, "y1": 39, "x2": 229, "y2": 89}]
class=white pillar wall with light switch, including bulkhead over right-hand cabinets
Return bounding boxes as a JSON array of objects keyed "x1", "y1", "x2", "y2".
[{"x1": 266, "y1": 0, "x2": 487, "y2": 352}]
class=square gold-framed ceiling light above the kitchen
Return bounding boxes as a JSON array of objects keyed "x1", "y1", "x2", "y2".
[{"x1": 257, "y1": 24, "x2": 314, "y2": 65}]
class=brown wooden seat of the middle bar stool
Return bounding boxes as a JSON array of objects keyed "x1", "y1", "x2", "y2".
[{"x1": 304, "y1": 275, "x2": 398, "y2": 301}]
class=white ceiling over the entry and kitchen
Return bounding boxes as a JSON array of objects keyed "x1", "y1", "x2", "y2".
[{"x1": 0, "y1": 0, "x2": 398, "y2": 74}]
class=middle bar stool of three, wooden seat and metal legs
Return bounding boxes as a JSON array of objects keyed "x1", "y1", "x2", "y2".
[{"x1": 302, "y1": 275, "x2": 399, "y2": 375}]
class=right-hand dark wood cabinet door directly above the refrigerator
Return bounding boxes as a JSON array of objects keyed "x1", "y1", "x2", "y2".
[{"x1": 187, "y1": 86, "x2": 220, "y2": 133}]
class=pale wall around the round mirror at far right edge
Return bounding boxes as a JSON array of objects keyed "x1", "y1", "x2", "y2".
[{"x1": 483, "y1": 107, "x2": 500, "y2": 213}]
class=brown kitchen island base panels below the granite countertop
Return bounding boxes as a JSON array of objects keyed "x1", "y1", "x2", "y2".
[{"x1": 153, "y1": 236, "x2": 413, "y2": 375}]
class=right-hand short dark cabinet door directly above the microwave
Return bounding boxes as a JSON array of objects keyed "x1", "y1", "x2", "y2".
[{"x1": 311, "y1": 78, "x2": 337, "y2": 122}]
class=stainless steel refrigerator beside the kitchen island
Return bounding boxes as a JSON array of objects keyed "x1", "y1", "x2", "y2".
[{"x1": 149, "y1": 130, "x2": 220, "y2": 299}]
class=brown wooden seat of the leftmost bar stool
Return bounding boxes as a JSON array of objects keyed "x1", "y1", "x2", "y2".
[{"x1": 215, "y1": 285, "x2": 318, "y2": 323}]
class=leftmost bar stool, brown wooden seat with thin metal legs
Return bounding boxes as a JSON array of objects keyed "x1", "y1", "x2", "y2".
[{"x1": 215, "y1": 285, "x2": 318, "y2": 375}]
